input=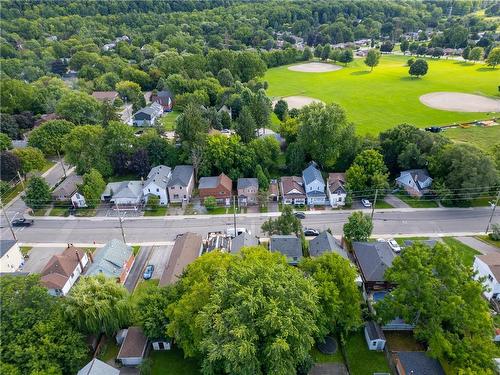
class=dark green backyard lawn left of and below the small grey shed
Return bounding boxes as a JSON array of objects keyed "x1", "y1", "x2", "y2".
[{"x1": 345, "y1": 330, "x2": 391, "y2": 375}]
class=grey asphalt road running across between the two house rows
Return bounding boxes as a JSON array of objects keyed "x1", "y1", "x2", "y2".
[{"x1": 0, "y1": 207, "x2": 500, "y2": 243}]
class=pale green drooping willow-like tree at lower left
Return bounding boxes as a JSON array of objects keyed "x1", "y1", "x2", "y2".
[{"x1": 63, "y1": 275, "x2": 132, "y2": 336}]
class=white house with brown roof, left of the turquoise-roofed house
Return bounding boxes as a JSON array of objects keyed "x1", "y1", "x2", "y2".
[{"x1": 40, "y1": 245, "x2": 89, "y2": 296}]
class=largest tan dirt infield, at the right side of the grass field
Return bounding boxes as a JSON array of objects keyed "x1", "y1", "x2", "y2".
[{"x1": 420, "y1": 92, "x2": 500, "y2": 112}]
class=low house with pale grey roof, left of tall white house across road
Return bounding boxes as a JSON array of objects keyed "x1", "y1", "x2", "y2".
[{"x1": 101, "y1": 181, "x2": 144, "y2": 210}]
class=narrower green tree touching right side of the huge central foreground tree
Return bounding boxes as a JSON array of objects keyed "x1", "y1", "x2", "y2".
[{"x1": 299, "y1": 253, "x2": 362, "y2": 340}]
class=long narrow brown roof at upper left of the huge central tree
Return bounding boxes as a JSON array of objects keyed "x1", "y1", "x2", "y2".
[{"x1": 159, "y1": 232, "x2": 203, "y2": 286}]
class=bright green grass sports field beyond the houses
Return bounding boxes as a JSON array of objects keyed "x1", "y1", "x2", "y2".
[{"x1": 264, "y1": 55, "x2": 500, "y2": 134}]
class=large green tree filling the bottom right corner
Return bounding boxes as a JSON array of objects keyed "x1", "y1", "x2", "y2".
[{"x1": 376, "y1": 243, "x2": 495, "y2": 374}]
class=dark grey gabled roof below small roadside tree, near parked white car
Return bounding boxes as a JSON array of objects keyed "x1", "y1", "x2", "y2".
[{"x1": 352, "y1": 241, "x2": 396, "y2": 281}]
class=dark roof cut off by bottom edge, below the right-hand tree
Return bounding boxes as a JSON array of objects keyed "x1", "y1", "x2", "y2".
[{"x1": 393, "y1": 352, "x2": 445, "y2": 375}]
